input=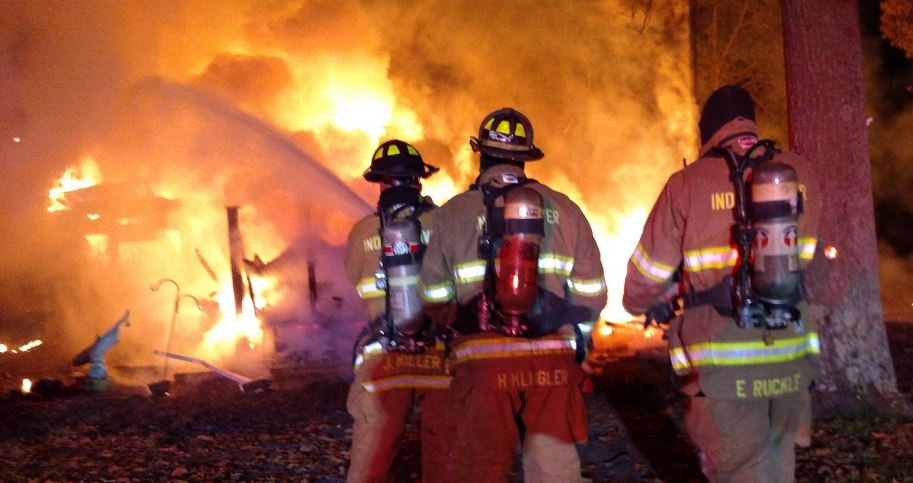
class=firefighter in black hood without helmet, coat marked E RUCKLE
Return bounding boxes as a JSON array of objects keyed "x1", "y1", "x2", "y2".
[{"x1": 623, "y1": 86, "x2": 819, "y2": 482}]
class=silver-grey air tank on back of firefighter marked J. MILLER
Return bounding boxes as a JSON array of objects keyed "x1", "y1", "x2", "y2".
[{"x1": 381, "y1": 219, "x2": 424, "y2": 336}]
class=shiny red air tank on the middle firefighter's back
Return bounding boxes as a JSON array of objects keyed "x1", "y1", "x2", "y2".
[{"x1": 495, "y1": 186, "x2": 545, "y2": 335}]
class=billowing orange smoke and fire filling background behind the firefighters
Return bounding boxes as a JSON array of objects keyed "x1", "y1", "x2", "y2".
[{"x1": 0, "y1": 0, "x2": 696, "y2": 374}]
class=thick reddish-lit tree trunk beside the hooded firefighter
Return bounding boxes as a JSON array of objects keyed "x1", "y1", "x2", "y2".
[{"x1": 782, "y1": 0, "x2": 901, "y2": 413}]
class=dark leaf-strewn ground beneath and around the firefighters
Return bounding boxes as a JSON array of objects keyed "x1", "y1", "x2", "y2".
[{"x1": 0, "y1": 323, "x2": 913, "y2": 482}]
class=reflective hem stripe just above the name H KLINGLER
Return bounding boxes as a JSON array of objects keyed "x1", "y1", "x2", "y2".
[{"x1": 453, "y1": 337, "x2": 577, "y2": 365}]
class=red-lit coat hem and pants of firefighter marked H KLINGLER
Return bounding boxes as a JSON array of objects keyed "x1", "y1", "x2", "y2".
[{"x1": 449, "y1": 332, "x2": 586, "y2": 483}]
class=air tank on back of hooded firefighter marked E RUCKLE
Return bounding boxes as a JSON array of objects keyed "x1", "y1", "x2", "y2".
[{"x1": 750, "y1": 160, "x2": 802, "y2": 327}]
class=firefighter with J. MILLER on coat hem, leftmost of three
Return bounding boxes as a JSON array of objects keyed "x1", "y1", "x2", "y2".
[{"x1": 345, "y1": 140, "x2": 450, "y2": 483}]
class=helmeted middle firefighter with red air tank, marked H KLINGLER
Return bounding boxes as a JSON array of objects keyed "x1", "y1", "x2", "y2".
[{"x1": 422, "y1": 108, "x2": 606, "y2": 482}]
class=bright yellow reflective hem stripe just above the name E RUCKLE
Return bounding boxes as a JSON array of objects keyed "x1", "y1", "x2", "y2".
[{"x1": 669, "y1": 332, "x2": 821, "y2": 371}]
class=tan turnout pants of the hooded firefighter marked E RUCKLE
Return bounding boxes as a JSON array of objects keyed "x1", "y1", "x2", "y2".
[{"x1": 685, "y1": 392, "x2": 811, "y2": 483}]
